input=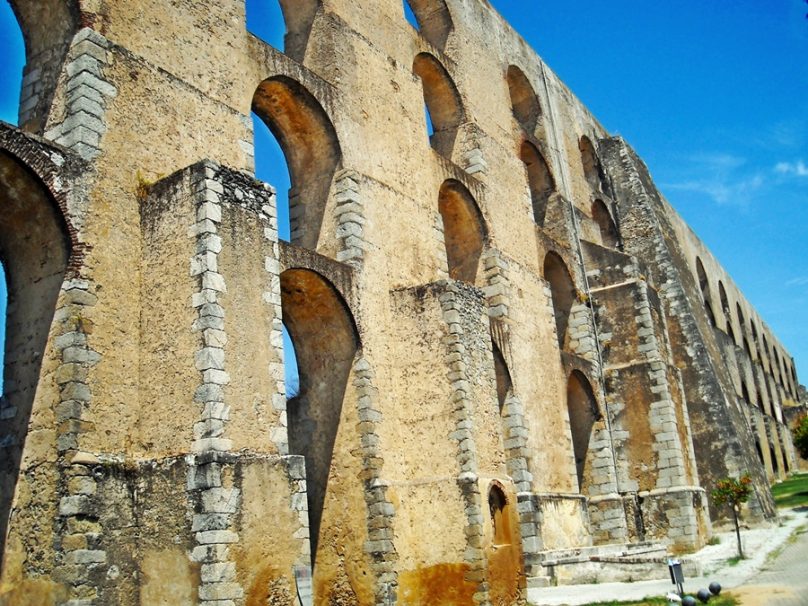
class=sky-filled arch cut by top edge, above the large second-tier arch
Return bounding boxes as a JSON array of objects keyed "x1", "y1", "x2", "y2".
[{"x1": 247, "y1": 0, "x2": 321, "y2": 63}]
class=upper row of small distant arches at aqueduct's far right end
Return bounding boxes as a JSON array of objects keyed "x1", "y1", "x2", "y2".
[{"x1": 695, "y1": 256, "x2": 798, "y2": 400}]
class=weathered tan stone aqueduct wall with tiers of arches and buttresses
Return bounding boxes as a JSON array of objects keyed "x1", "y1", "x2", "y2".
[{"x1": 0, "y1": 0, "x2": 804, "y2": 606}]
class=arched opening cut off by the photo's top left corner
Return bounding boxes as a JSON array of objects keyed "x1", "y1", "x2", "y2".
[{"x1": 0, "y1": 0, "x2": 79, "y2": 133}]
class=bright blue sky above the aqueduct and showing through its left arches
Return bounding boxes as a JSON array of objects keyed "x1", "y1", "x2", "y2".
[{"x1": 0, "y1": 0, "x2": 808, "y2": 392}]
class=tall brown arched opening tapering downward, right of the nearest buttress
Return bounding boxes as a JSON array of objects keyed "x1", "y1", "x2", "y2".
[{"x1": 281, "y1": 269, "x2": 358, "y2": 556}]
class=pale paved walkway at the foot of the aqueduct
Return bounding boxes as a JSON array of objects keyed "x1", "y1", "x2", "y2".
[{"x1": 528, "y1": 511, "x2": 808, "y2": 606}]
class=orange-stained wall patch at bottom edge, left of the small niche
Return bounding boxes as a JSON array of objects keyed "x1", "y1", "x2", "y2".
[{"x1": 398, "y1": 564, "x2": 477, "y2": 606}]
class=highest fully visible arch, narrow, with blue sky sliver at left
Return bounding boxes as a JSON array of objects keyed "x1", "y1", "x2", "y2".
[{"x1": 412, "y1": 53, "x2": 465, "y2": 158}]
